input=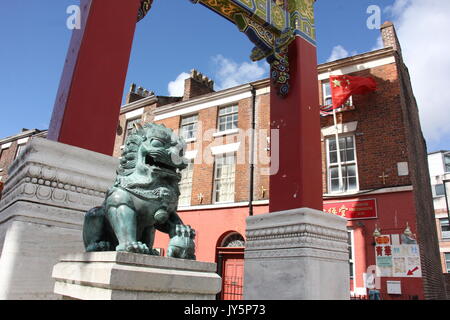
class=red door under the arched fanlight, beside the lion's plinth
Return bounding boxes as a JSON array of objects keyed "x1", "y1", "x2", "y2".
[{"x1": 221, "y1": 252, "x2": 244, "y2": 300}]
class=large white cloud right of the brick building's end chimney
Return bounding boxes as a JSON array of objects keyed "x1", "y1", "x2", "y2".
[{"x1": 385, "y1": 0, "x2": 450, "y2": 151}]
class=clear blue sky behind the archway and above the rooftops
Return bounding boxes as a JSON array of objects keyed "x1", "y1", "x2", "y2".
[{"x1": 0, "y1": 0, "x2": 450, "y2": 151}]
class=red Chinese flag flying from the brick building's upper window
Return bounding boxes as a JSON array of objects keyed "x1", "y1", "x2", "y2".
[{"x1": 330, "y1": 75, "x2": 377, "y2": 108}]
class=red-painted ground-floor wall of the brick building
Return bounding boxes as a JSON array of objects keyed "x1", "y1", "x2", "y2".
[{"x1": 155, "y1": 191, "x2": 424, "y2": 300}]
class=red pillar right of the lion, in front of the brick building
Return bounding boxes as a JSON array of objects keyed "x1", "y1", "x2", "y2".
[{"x1": 269, "y1": 37, "x2": 323, "y2": 212}]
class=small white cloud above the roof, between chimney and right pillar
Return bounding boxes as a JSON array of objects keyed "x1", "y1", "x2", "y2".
[{"x1": 212, "y1": 54, "x2": 270, "y2": 90}]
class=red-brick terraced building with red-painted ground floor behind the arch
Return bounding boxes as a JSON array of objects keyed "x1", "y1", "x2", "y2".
[{"x1": 0, "y1": 23, "x2": 446, "y2": 299}]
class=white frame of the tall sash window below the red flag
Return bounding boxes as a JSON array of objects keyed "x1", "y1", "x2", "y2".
[{"x1": 325, "y1": 133, "x2": 359, "y2": 194}]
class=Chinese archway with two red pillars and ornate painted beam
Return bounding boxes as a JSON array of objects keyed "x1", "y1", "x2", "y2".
[{"x1": 48, "y1": 0, "x2": 322, "y2": 212}]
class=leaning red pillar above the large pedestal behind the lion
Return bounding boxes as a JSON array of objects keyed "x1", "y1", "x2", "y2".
[{"x1": 48, "y1": 0, "x2": 141, "y2": 155}]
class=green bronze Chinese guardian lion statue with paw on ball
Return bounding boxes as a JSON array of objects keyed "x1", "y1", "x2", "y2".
[{"x1": 83, "y1": 123, "x2": 195, "y2": 260}]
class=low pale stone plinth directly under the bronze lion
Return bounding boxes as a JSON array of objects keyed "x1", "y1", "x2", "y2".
[{"x1": 53, "y1": 252, "x2": 222, "y2": 300}]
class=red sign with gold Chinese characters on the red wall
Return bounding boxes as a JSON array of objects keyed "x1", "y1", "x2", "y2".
[{"x1": 323, "y1": 199, "x2": 377, "y2": 220}]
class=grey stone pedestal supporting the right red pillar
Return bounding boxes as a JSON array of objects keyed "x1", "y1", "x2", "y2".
[{"x1": 244, "y1": 208, "x2": 350, "y2": 300}]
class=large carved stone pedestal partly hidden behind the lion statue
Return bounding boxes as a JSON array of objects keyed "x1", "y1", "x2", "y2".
[{"x1": 0, "y1": 138, "x2": 118, "y2": 300}]
